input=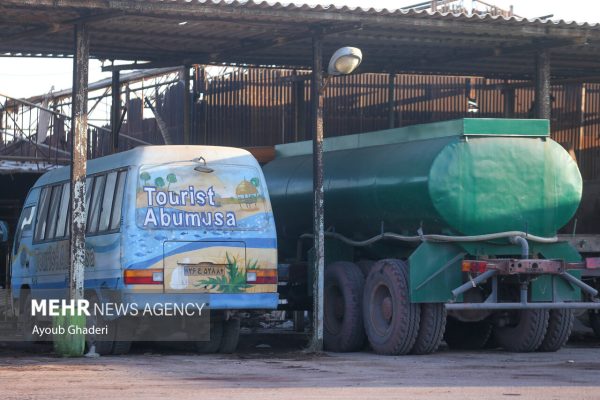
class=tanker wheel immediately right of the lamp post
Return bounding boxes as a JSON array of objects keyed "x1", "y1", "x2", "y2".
[{"x1": 323, "y1": 261, "x2": 365, "y2": 352}]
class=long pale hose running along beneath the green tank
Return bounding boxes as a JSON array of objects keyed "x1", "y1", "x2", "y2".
[{"x1": 300, "y1": 231, "x2": 558, "y2": 247}]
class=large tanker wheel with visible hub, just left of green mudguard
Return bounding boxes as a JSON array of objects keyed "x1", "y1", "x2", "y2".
[{"x1": 363, "y1": 260, "x2": 421, "y2": 355}]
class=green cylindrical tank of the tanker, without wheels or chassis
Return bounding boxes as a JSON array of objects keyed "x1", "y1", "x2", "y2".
[{"x1": 263, "y1": 119, "x2": 582, "y2": 256}]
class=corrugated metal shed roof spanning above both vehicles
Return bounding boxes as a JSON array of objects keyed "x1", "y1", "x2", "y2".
[{"x1": 0, "y1": 0, "x2": 600, "y2": 79}]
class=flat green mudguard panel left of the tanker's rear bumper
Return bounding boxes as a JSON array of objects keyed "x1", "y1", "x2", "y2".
[{"x1": 408, "y1": 242, "x2": 467, "y2": 303}]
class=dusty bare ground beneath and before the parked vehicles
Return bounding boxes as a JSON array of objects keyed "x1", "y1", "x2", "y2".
[{"x1": 0, "y1": 335, "x2": 600, "y2": 400}]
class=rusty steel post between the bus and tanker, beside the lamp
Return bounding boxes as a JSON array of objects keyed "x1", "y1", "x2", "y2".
[{"x1": 310, "y1": 34, "x2": 325, "y2": 351}]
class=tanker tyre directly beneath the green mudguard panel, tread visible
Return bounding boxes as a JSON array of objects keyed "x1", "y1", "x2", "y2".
[{"x1": 410, "y1": 303, "x2": 446, "y2": 355}]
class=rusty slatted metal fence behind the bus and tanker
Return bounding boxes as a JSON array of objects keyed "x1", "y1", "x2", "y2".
[{"x1": 0, "y1": 66, "x2": 600, "y2": 180}]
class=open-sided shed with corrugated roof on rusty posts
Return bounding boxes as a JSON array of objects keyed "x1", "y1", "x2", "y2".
[{"x1": 0, "y1": 0, "x2": 600, "y2": 347}]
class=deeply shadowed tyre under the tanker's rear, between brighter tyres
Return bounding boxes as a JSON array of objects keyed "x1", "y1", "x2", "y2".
[{"x1": 444, "y1": 317, "x2": 492, "y2": 350}]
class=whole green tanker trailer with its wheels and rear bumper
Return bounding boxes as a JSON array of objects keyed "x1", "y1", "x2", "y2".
[{"x1": 263, "y1": 119, "x2": 598, "y2": 354}]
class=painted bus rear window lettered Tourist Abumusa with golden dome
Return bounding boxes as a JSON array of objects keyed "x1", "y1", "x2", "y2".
[{"x1": 136, "y1": 164, "x2": 269, "y2": 230}]
